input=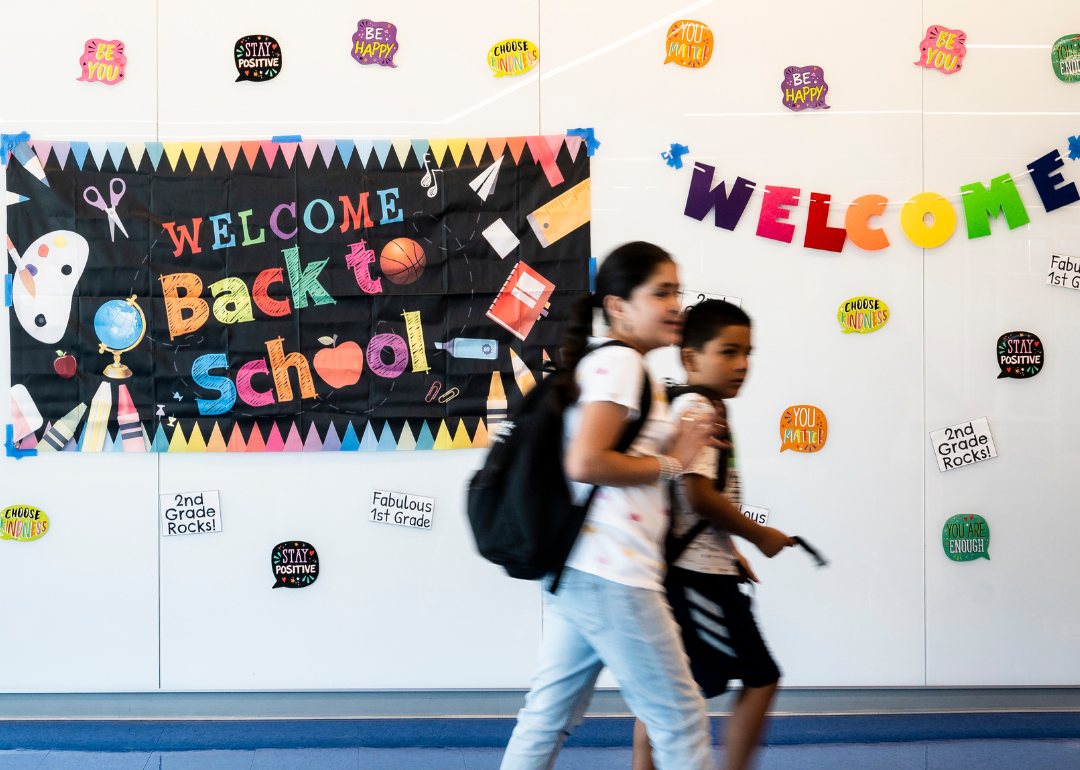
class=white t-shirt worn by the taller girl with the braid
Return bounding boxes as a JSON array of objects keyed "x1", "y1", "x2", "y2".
[{"x1": 564, "y1": 340, "x2": 674, "y2": 591}]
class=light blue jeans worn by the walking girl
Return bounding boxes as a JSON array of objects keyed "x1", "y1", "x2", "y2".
[{"x1": 502, "y1": 568, "x2": 714, "y2": 770}]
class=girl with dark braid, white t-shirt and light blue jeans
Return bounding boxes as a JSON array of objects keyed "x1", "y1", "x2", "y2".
[{"x1": 502, "y1": 242, "x2": 719, "y2": 770}]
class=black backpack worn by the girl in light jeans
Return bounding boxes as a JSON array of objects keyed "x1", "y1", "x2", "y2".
[{"x1": 468, "y1": 340, "x2": 652, "y2": 593}]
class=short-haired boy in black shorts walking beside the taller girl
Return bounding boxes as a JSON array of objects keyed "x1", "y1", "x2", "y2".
[{"x1": 633, "y1": 300, "x2": 795, "y2": 770}]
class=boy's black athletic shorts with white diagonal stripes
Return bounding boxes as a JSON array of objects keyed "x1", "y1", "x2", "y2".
[{"x1": 666, "y1": 567, "x2": 780, "y2": 698}]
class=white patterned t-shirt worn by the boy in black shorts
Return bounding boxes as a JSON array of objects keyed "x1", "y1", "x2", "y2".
[{"x1": 671, "y1": 393, "x2": 742, "y2": 576}]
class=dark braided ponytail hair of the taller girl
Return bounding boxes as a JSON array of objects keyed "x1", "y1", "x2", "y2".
[{"x1": 555, "y1": 241, "x2": 673, "y2": 408}]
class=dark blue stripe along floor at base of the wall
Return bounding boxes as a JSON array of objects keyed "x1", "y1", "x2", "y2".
[{"x1": 0, "y1": 712, "x2": 1080, "y2": 752}]
